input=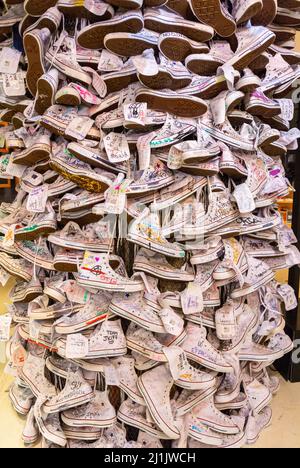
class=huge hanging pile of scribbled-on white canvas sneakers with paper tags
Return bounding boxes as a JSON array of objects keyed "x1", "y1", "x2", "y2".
[{"x1": 0, "y1": 0, "x2": 300, "y2": 448}]
